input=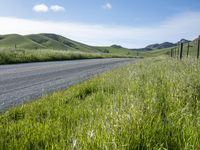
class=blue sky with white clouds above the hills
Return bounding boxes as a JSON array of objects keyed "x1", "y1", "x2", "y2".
[{"x1": 0, "y1": 0, "x2": 200, "y2": 48}]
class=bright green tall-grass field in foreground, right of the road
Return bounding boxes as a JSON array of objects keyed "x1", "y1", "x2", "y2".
[{"x1": 0, "y1": 58, "x2": 200, "y2": 150}]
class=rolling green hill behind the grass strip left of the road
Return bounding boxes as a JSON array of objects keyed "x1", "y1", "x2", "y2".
[{"x1": 0, "y1": 33, "x2": 136, "y2": 55}]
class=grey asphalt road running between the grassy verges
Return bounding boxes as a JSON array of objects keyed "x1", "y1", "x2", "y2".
[{"x1": 0, "y1": 58, "x2": 136, "y2": 112}]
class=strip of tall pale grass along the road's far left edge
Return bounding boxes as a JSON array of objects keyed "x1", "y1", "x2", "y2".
[{"x1": 0, "y1": 49, "x2": 136, "y2": 64}]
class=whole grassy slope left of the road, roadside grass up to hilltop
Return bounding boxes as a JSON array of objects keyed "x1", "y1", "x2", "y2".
[{"x1": 0, "y1": 33, "x2": 136, "y2": 64}]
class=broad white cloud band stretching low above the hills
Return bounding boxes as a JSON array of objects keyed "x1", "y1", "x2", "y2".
[{"x1": 0, "y1": 12, "x2": 200, "y2": 48}]
